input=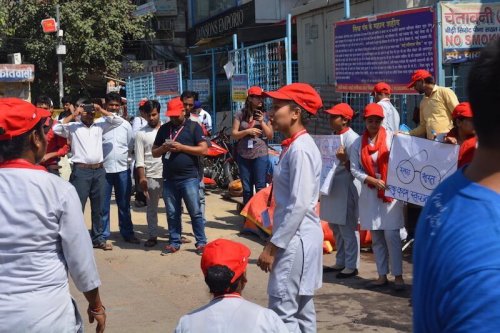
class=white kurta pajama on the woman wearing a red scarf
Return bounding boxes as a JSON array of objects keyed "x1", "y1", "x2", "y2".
[{"x1": 350, "y1": 131, "x2": 404, "y2": 276}]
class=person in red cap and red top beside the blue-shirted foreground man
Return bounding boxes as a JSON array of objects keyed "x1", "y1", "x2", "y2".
[{"x1": 445, "y1": 102, "x2": 477, "y2": 168}]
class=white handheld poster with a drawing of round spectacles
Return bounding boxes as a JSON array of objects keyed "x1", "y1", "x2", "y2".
[{"x1": 385, "y1": 134, "x2": 459, "y2": 206}]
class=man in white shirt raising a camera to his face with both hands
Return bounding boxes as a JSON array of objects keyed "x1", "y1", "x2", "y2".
[{"x1": 53, "y1": 98, "x2": 124, "y2": 251}]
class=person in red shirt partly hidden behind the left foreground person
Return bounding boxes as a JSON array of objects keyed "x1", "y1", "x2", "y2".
[{"x1": 36, "y1": 96, "x2": 69, "y2": 176}]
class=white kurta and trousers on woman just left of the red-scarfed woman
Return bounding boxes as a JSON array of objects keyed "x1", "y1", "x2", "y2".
[{"x1": 320, "y1": 128, "x2": 361, "y2": 269}]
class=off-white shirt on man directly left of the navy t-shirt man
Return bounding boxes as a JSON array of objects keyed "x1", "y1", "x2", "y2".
[{"x1": 135, "y1": 126, "x2": 163, "y2": 178}]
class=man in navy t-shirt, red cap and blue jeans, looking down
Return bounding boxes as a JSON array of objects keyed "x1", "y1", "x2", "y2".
[{"x1": 152, "y1": 98, "x2": 208, "y2": 255}]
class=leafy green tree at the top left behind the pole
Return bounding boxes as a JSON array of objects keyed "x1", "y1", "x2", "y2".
[{"x1": 0, "y1": 0, "x2": 152, "y2": 103}]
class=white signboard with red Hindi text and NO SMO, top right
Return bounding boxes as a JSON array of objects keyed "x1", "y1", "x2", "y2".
[{"x1": 439, "y1": 2, "x2": 500, "y2": 64}]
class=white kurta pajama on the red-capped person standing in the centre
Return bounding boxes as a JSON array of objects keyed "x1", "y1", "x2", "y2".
[{"x1": 268, "y1": 134, "x2": 323, "y2": 332}]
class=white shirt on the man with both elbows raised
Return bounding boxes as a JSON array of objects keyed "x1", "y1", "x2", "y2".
[{"x1": 53, "y1": 115, "x2": 124, "y2": 164}]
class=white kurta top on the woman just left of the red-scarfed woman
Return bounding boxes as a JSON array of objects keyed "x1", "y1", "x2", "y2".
[{"x1": 320, "y1": 128, "x2": 361, "y2": 225}]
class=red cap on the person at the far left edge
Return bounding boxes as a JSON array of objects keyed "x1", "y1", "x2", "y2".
[{"x1": 0, "y1": 98, "x2": 50, "y2": 140}]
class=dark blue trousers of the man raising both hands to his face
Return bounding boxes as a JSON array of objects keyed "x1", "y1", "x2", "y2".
[{"x1": 69, "y1": 166, "x2": 106, "y2": 245}]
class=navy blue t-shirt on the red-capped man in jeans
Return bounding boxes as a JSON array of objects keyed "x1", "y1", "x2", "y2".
[{"x1": 154, "y1": 119, "x2": 205, "y2": 180}]
